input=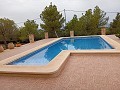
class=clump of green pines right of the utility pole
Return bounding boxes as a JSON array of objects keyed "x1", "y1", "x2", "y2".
[{"x1": 66, "y1": 6, "x2": 109, "y2": 35}]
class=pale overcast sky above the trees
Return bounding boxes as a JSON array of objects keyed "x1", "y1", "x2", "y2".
[{"x1": 0, "y1": 0, "x2": 120, "y2": 27}]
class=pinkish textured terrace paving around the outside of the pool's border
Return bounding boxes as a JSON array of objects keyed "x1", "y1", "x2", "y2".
[{"x1": 0, "y1": 36, "x2": 120, "y2": 90}]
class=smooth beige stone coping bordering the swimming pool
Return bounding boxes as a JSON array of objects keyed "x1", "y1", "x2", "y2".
[{"x1": 0, "y1": 35, "x2": 120, "y2": 77}]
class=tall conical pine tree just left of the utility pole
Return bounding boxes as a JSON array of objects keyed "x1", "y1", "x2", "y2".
[{"x1": 40, "y1": 3, "x2": 64, "y2": 37}]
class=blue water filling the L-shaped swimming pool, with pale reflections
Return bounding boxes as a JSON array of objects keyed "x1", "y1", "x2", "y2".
[{"x1": 8, "y1": 36, "x2": 113, "y2": 65}]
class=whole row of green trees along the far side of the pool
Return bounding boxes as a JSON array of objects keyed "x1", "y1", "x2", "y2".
[{"x1": 0, "y1": 3, "x2": 120, "y2": 46}]
